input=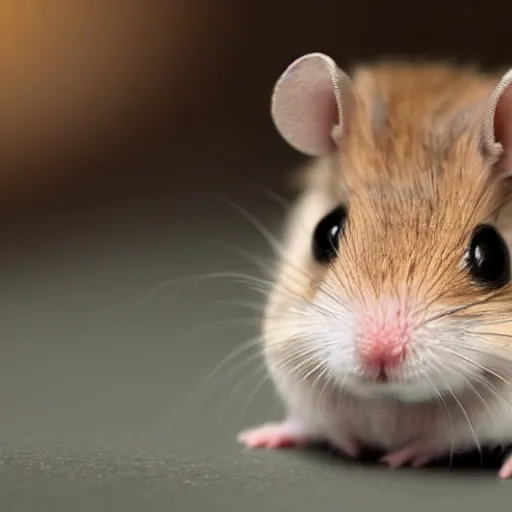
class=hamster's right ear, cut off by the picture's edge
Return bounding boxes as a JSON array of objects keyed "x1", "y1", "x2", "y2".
[{"x1": 483, "y1": 69, "x2": 512, "y2": 178}]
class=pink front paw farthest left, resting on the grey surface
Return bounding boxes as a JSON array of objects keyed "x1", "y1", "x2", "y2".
[{"x1": 238, "y1": 421, "x2": 312, "y2": 449}]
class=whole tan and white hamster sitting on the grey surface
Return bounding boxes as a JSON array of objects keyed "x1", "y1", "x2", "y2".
[{"x1": 238, "y1": 53, "x2": 512, "y2": 478}]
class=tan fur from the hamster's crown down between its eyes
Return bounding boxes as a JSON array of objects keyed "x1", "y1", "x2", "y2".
[{"x1": 294, "y1": 64, "x2": 512, "y2": 322}]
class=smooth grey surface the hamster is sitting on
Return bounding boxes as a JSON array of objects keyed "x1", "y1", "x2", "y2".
[{"x1": 0, "y1": 149, "x2": 512, "y2": 512}]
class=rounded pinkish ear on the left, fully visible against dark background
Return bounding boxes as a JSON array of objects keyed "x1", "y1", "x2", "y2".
[{"x1": 271, "y1": 53, "x2": 350, "y2": 156}]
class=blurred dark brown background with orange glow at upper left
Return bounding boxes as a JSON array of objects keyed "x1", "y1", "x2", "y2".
[{"x1": 0, "y1": 0, "x2": 512, "y2": 214}]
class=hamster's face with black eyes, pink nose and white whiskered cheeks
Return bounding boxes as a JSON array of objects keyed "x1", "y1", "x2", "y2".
[{"x1": 265, "y1": 148, "x2": 512, "y2": 402}]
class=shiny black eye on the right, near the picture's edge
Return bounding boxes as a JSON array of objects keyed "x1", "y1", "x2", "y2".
[{"x1": 467, "y1": 224, "x2": 510, "y2": 288}]
